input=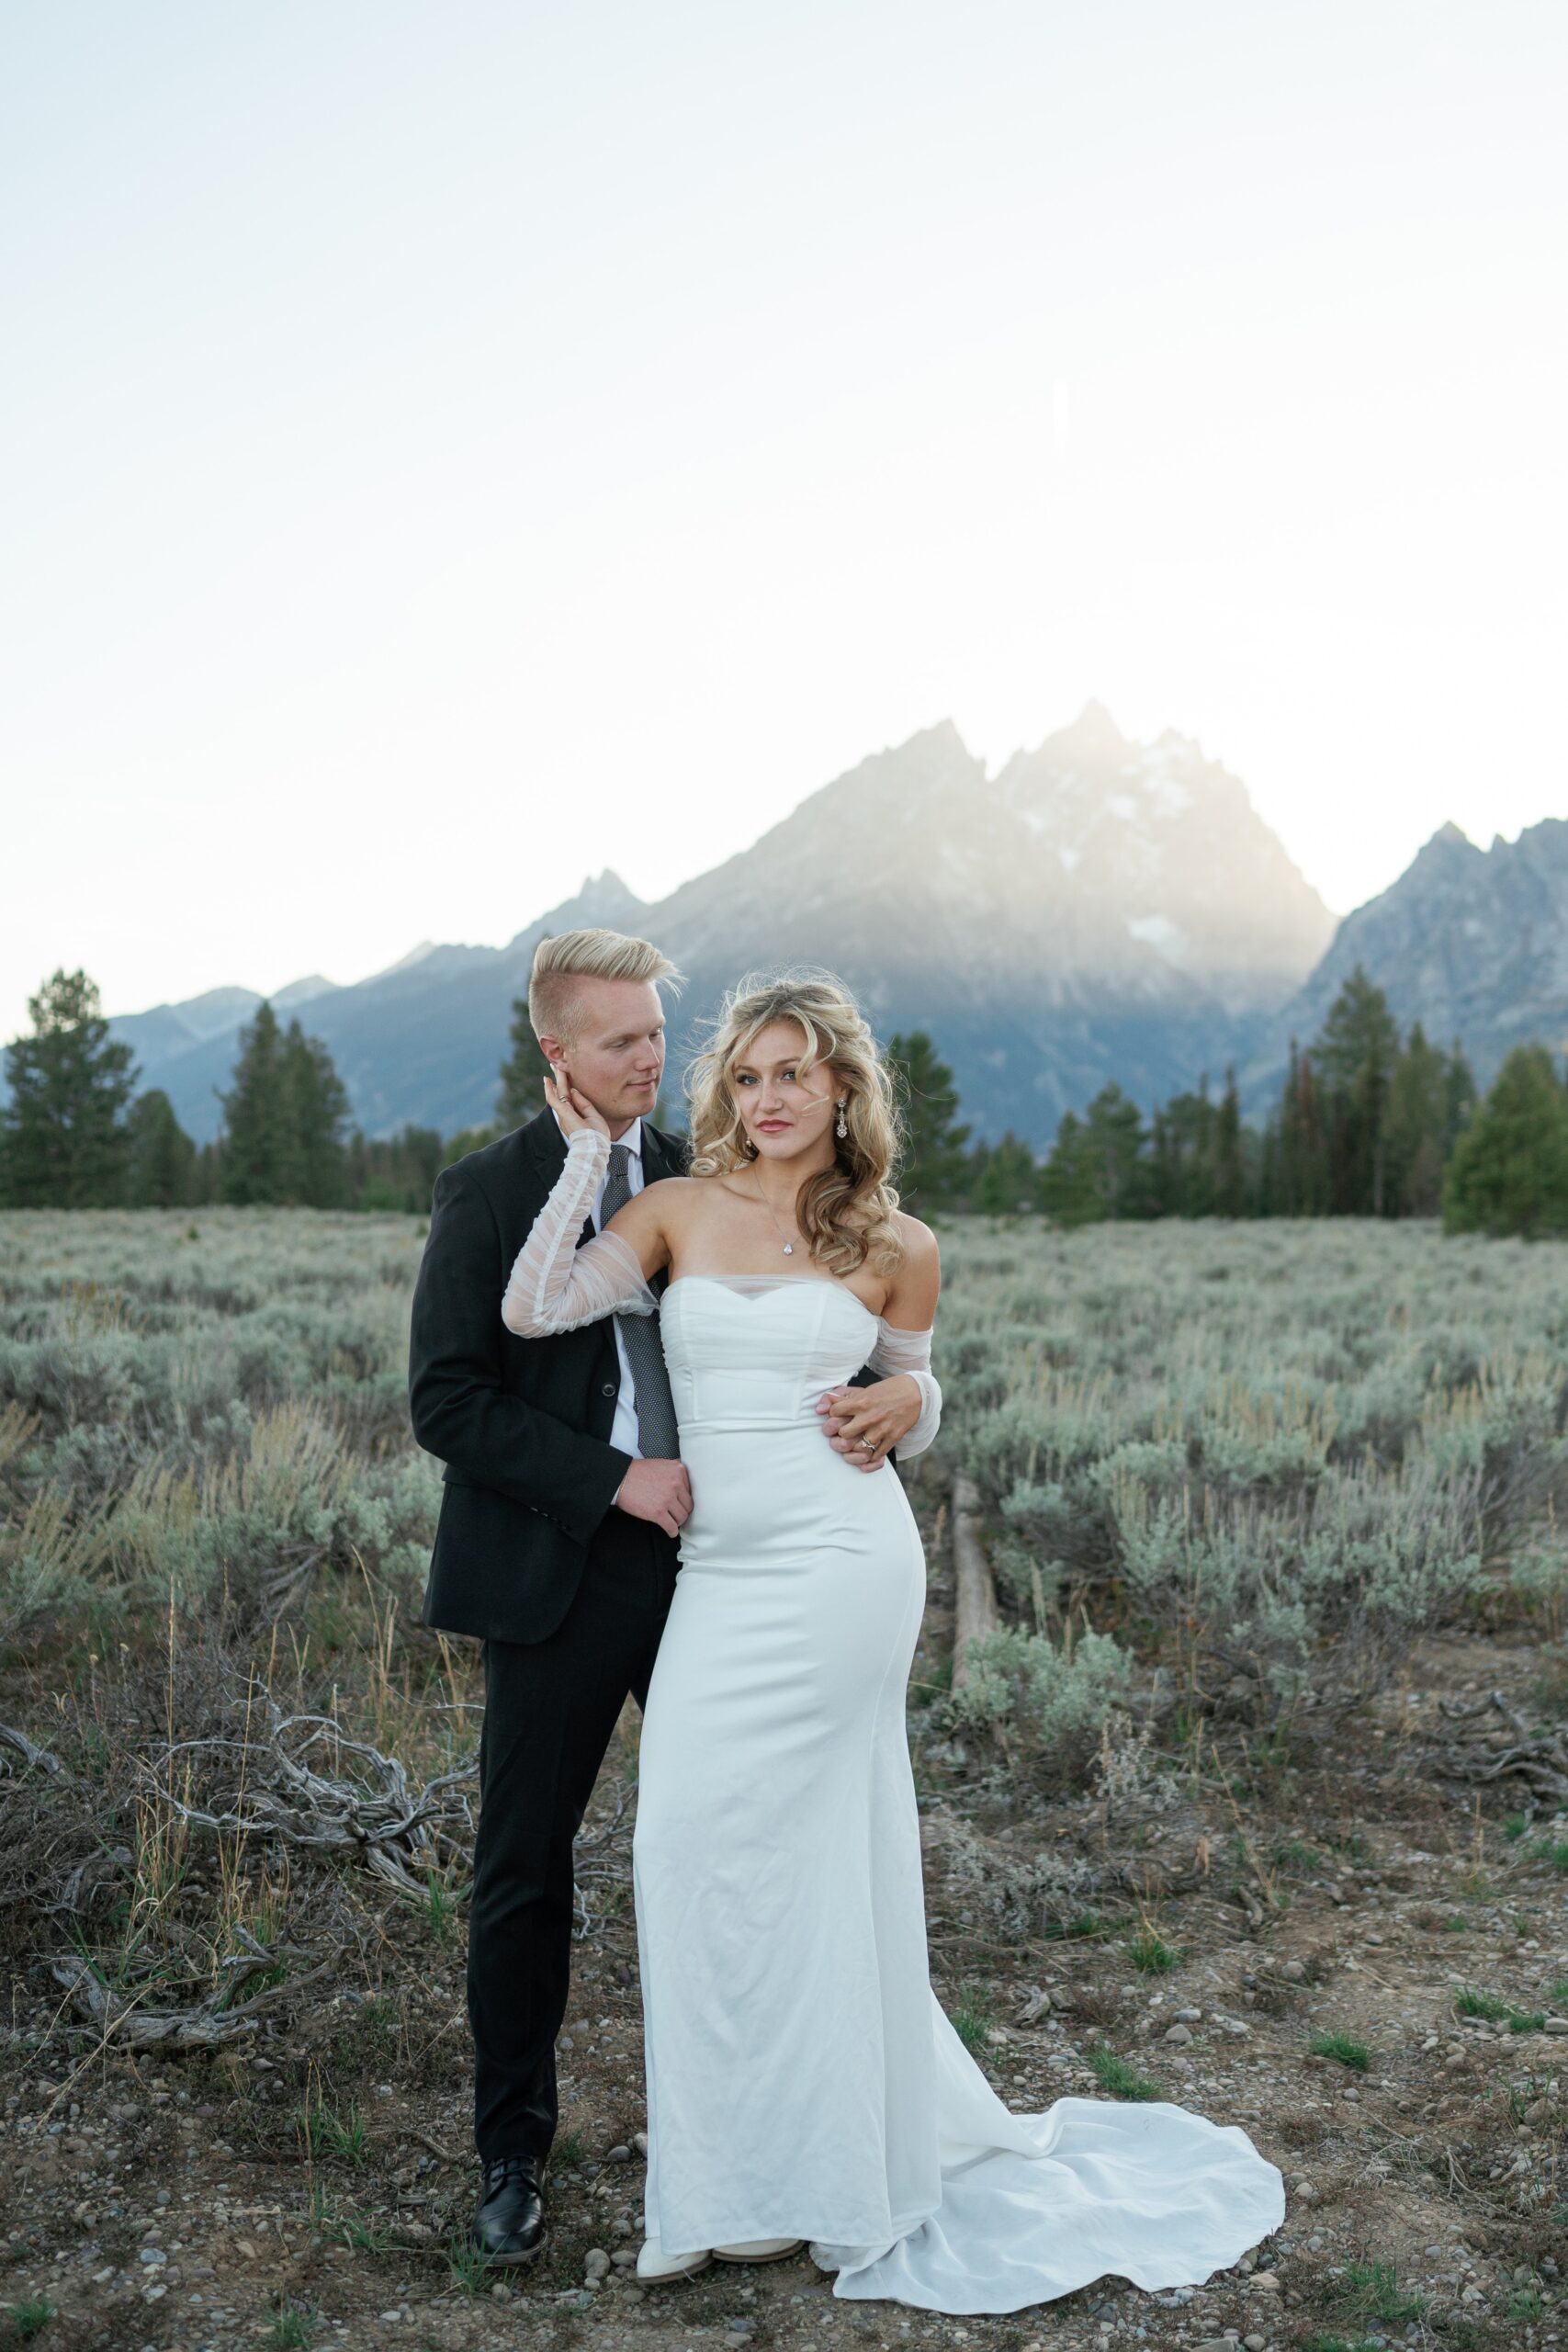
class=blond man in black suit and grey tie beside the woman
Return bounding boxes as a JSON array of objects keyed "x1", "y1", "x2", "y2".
[{"x1": 409, "y1": 932, "x2": 919, "y2": 2263}]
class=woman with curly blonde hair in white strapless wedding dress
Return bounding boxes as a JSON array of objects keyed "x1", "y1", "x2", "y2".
[{"x1": 501, "y1": 978, "x2": 1283, "y2": 2314}]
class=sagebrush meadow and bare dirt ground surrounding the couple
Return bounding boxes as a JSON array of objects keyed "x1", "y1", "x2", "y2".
[{"x1": 0, "y1": 1209, "x2": 1568, "y2": 2352}]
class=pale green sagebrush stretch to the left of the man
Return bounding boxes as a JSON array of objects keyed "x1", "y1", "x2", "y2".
[{"x1": 0, "y1": 1209, "x2": 440, "y2": 1639}]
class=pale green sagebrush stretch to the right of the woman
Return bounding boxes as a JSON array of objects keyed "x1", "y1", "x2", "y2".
[{"x1": 938, "y1": 1218, "x2": 1568, "y2": 1719}]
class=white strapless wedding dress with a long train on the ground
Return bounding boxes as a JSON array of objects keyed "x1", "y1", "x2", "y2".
[{"x1": 635, "y1": 1275, "x2": 1283, "y2": 2312}]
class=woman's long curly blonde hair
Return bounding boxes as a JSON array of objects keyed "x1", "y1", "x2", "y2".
[{"x1": 686, "y1": 971, "x2": 903, "y2": 1277}]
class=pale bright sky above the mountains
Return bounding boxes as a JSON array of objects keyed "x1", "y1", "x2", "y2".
[{"x1": 0, "y1": 0, "x2": 1568, "y2": 1035}]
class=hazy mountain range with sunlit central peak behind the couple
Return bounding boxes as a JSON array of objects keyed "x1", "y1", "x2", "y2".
[{"x1": 101, "y1": 703, "x2": 1333, "y2": 1143}]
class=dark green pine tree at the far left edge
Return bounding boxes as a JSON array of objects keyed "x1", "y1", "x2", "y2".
[{"x1": 0, "y1": 971, "x2": 136, "y2": 1209}]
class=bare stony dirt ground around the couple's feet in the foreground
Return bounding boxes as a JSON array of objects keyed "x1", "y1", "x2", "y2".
[{"x1": 0, "y1": 1585, "x2": 1568, "y2": 2352}]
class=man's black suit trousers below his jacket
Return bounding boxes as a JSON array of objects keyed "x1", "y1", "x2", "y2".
[{"x1": 468, "y1": 1508, "x2": 677, "y2": 2164}]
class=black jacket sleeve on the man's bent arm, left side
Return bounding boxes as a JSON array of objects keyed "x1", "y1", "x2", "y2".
[{"x1": 409, "y1": 1167, "x2": 630, "y2": 1545}]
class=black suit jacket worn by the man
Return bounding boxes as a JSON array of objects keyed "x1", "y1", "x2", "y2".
[{"x1": 409, "y1": 1110, "x2": 686, "y2": 1642}]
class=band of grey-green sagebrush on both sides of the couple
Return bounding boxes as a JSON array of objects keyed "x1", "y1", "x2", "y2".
[{"x1": 0, "y1": 1209, "x2": 1568, "y2": 1755}]
